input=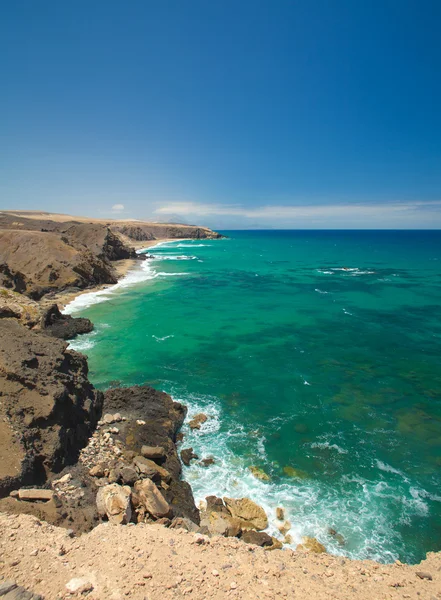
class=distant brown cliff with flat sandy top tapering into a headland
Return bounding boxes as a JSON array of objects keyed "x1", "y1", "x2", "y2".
[{"x1": 0, "y1": 211, "x2": 221, "y2": 300}]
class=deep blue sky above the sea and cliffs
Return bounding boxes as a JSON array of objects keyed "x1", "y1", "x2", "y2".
[{"x1": 0, "y1": 0, "x2": 441, "y2": 229}]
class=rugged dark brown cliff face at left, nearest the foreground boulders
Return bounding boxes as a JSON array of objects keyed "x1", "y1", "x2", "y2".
[{"x1": 0, "y1": 319, "x2": 103, "y2": 496}]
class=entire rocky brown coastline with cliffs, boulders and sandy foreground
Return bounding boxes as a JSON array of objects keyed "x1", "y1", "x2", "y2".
[{"x1": 0, "y1": 213, "x2": 441, "y2": 600}]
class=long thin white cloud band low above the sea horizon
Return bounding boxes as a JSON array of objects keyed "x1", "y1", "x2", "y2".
[{"x1": 155, "y1": 201, "x2": 441, "y2": 229}]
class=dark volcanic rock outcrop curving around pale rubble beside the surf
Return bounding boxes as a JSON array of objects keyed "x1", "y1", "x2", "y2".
[{"x1": 104, "y1": 385, "x2": 199, "y2": 523}]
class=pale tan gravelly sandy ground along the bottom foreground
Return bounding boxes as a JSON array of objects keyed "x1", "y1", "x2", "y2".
[{"x1": 0, "y1": 513, "x2": 441, "y2": 600}]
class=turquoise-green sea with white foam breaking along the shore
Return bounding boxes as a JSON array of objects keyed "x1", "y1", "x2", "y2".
[{"x1": 68, "y1": 231, "x2": 441, "y2": 562}]
